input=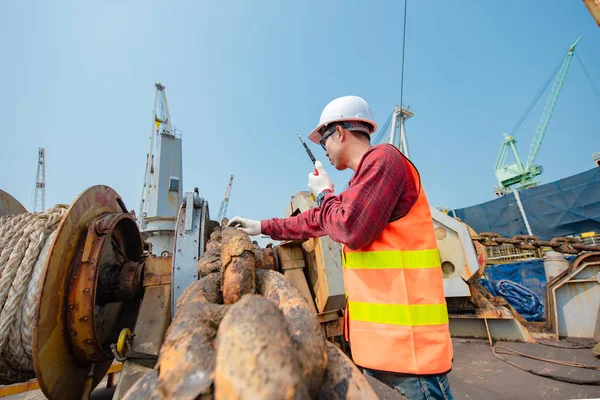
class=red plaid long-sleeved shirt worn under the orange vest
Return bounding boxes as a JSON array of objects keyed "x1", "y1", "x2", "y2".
[{"x1": 261, "y1": 144, "x2": 418, "y2": 249}]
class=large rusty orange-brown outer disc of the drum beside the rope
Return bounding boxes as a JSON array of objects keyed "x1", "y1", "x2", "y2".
[{"x1": 33, "y1": 185, "x2": 122, "y2": 400}]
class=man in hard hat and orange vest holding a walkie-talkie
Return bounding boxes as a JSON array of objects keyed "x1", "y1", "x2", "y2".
[{"x1": 229, "y1": 96, "x2": 453, "y2": 399}]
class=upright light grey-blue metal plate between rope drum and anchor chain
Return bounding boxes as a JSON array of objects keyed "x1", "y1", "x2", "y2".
[{"x1": 171, "y1": 193, "x2": 208, "y2": 315}]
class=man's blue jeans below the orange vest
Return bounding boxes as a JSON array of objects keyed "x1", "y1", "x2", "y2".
[{"x1": 364, "y1": 368, "x2": 454, "y2": 400}]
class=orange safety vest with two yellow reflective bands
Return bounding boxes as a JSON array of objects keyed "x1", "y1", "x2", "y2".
[{"x1": 343, "y1": 151, "x2": 453, "y2": 375}]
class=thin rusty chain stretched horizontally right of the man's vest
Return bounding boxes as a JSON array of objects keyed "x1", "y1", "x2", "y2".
[{"x1": 471, "y1": 232, "x2": 600, "y2": 254}]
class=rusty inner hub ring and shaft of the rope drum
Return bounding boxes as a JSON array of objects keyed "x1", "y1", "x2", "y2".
[{"x1": 66, "y1": 213, "x2": 143, "y2": 364}]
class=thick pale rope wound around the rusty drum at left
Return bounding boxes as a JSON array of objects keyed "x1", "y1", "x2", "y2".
[{"x1": 0, "y1": 205, "x2": 67, "y2": 384}]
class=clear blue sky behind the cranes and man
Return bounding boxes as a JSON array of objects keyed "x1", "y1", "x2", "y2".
[{"x1": 0, "y1": 0, "x2": 600, "y2": 219}]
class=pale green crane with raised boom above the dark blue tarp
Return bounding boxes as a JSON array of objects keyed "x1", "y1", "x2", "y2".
[{"x1": 494, "y1": 37, "x2": 581, "y2": 194}]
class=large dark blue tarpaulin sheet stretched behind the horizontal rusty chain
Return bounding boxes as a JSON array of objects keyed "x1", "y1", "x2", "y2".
[{"x1": 453, "y1": 168, "x2": 600, "y2": 240}]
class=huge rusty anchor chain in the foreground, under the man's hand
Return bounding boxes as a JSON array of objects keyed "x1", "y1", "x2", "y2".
[{"x1": 119, "y1": 227, "x2": 377, "y2": 400}]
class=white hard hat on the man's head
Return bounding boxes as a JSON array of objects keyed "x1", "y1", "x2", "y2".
[{"x1": 308, "y1": 96, "x2": 377, "y2": 144}]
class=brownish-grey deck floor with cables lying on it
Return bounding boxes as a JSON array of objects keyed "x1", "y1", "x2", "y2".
[{"x1": 2, "y1": 338, "x2": 600, "y2": 400}]
